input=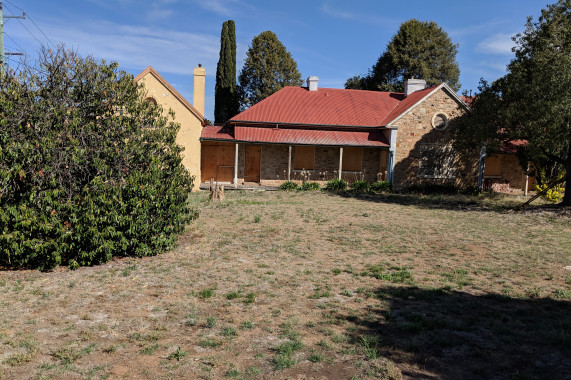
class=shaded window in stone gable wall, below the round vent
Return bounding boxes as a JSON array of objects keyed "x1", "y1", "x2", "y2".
[{"x1": 418, "y1": 144, "x2": 456, "y2": 179}]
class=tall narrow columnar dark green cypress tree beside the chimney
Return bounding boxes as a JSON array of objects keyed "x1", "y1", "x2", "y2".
[{"x1": 214, "y1": 20, "x2": 238, "y2": 123}]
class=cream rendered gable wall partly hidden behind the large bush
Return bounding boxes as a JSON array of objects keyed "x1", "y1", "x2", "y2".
[{"x1": 140, "y1": 73, "x2": 202, "y2": 190}]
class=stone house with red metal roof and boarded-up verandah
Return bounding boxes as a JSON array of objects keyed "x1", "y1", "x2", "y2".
[{"x1": 200, "y1": 77, "x2": 476, "y2": 190}]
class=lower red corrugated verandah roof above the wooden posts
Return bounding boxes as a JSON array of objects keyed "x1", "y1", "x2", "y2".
[{"x1": 234, "y1": 126, "x2": 389, "y2": 147}]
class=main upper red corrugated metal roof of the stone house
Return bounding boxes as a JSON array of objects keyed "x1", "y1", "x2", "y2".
[{"x1": 230, "y1": 87, "x2": 404, "y2": 127}]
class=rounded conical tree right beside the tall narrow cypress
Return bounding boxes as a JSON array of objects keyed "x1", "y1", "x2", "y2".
[{"x1": 239, "y1": 31, "x2": 303, "y2": 109}]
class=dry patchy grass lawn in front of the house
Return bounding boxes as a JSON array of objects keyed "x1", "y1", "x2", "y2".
[{"x1": 0, "y1": 192, "x2": 571, "y2": 379}]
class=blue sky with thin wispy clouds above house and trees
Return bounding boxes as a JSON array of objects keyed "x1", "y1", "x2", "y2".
[{"x1": 3, "y1": 0, "x2": 547, "y2": 120}]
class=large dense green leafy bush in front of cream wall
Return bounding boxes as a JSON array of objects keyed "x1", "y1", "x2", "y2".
[{"x1": 0, "y1": 49, "x2": 196, "y2": 269}]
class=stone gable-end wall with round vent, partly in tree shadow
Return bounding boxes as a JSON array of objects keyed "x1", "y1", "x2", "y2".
[{"x1": 393, "y1": 88, "x2": 478, "y2": 190}]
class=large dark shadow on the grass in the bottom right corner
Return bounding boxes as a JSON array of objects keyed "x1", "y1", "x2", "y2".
[{"x1": 347, "y1": 286, "x2": 571, "y2": 379}]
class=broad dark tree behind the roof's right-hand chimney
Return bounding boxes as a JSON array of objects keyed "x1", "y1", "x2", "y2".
[{"x1": 345, "y1": 19, "x2": 460, "y2": 92}]
